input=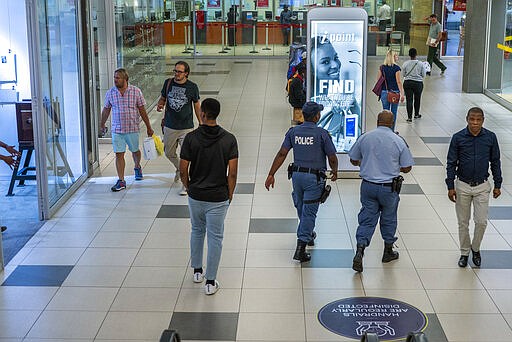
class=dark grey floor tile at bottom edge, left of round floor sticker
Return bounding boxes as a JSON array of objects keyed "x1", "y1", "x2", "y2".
[{"x1": 169, "y1": 312, "x2": 238, "y2": 341}]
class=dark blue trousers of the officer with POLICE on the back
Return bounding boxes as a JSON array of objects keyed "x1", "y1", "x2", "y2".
[{"x1": 292, "y1": 172, "x2": 325, "y2": 242}]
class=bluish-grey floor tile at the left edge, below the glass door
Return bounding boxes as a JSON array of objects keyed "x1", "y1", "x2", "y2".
[{"x1": 2, "y1": 265, "x2": 73, "y2": 286}]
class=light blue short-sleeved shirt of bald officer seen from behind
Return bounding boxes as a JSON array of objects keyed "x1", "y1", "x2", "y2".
[{"x1": 348, "y1": 126, "x2": 414, "y2": 183}]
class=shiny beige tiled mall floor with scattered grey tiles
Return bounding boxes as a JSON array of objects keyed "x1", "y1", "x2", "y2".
[{"x1": 0, "y1": 59, "x2": 512, "y2": 342}]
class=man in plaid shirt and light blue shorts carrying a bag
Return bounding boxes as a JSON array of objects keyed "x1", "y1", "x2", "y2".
[{"x1": 101, "y1": 69, "x2": 153, "y2": 191}]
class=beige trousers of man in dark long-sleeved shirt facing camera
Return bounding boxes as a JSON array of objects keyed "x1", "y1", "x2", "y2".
[{"x1": 455, "y1": 179, "x2": 491, "y2": 255}]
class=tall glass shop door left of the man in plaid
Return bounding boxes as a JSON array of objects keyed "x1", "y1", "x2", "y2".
[{"x1": 27, "y1": 0, "x2": 87, "y2": 218}]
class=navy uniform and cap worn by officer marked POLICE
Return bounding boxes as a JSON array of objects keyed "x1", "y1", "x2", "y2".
[{"x1": 281, "y1": 102, "x2": 336, "y2": 258}]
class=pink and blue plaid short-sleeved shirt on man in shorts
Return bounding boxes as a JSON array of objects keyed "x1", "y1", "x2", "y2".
[{"x1": 105, "y1": 85, "x2": 146, "y2": 133}]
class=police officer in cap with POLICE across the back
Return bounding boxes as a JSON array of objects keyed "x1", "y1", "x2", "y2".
[{"x1": 265, "y1": 102, "x2": 338, "y2": 262}]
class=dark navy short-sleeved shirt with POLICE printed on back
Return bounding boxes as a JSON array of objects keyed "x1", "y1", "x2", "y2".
[{"x1": 281, "y1": 121, "x2": 336, "y2": 171}]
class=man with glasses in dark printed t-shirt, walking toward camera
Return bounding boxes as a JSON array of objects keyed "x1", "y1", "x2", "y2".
[{"x1": 157, "y1": 61, "x2": 201, "y2": 195}]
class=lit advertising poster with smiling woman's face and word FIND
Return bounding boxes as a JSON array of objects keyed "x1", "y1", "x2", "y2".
[{"x1": 309, "y1": 20, "x2": 365, "y2": 152}]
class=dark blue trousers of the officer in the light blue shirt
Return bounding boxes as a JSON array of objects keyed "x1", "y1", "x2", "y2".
[{"x1": 356, "y1": 181, "x2": 400, "y2": 246}]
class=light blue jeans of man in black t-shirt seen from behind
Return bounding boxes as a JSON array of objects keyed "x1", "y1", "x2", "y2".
[{"x1": 188, "y1": 197, "x2": 229, "y2": 280}]
